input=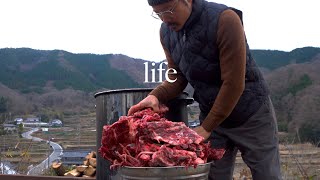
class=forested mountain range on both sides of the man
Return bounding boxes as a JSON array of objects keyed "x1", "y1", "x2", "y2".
[{"x1": 0, "y1": 47, "x2": 320, "y2": 143}]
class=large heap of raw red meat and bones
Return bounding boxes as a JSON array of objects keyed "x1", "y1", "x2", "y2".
[{"x1": 99, "y1": 109, "x2": 225, "y2": 169}]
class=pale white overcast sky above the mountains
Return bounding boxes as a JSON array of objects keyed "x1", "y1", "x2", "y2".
[{"x1": 0, "y1": 0, "x2": 320, "y2": 62}]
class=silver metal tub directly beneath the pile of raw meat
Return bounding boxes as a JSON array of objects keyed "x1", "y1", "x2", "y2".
[{"x1": 119, "y1": 163, "x2": 210, "y2": 180}]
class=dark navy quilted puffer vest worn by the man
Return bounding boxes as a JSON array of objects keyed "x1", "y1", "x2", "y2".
[{"x1": 161, "y1": 0, "x2": 268, "y2": 128}]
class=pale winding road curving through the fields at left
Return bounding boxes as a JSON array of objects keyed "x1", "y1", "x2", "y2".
[{"x1": 22, "y1": 128, "x2": 63, "y2": 175}]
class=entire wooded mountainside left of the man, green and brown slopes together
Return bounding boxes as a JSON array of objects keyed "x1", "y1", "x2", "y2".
[{"x1": 0, "y1": 48, "x2": 164, "y2": 115}]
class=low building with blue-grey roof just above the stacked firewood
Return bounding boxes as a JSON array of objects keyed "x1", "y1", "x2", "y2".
[{"x1": 61, "y1": 150, "x2": 90, "y2": 165}]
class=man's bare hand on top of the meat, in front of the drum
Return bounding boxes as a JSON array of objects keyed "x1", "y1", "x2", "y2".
[{"x1": 128, "y1": 95, "x2": 161, "y2": 116}]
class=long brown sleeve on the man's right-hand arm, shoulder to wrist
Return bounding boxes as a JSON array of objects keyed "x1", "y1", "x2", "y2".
[{"x1": 202, "y1": 9, "x2": 246, "y2": 132}]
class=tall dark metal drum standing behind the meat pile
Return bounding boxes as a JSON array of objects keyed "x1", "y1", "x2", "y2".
[{"x1": 94, "y1": 88, "x2": 193, "y2": 180}]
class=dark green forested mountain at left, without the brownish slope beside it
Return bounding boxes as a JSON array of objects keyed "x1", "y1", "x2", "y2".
[{"x1": 0, "y1": 48, "x2": 140, "y2": 94}]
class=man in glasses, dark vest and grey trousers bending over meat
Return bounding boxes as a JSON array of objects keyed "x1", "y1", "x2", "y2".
[{"x1": 128, "y1": 0, "x2": 281, "y2": 180}]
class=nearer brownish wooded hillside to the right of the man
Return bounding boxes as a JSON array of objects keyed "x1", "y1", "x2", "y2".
[{"x1": 265, "y1": 55, "x2": 320, "y2": 142}]
